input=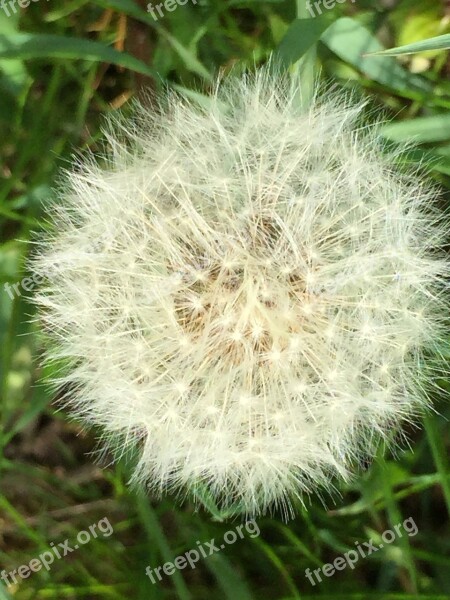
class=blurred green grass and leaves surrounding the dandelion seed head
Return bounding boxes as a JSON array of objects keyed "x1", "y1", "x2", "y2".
[{"x1": 0, "y1": 0, "x2": 450, "y2": 600}]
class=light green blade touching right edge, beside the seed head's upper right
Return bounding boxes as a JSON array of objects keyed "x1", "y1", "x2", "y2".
[{"x1": 381, "y1": 113, "x2": 450, "y2": 144}]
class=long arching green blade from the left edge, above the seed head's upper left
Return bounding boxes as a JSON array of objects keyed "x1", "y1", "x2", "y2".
[{"x1": 0, "y1": 33, "x2": 155, "y2": 77}]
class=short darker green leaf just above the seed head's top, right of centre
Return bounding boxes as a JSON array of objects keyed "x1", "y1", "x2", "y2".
[{"x1": 274, "y1": 17, "x2": 329, "y2": 67}]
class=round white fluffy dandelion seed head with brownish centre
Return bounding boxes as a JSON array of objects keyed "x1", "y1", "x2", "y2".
[{"x1": 33, "y1": 64, "x2": 448, "y2": 514}]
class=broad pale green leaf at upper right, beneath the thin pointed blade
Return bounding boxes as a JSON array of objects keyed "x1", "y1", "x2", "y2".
[{"x1": 321, "y1": 17, "x2": 432, "y2": 97}]
